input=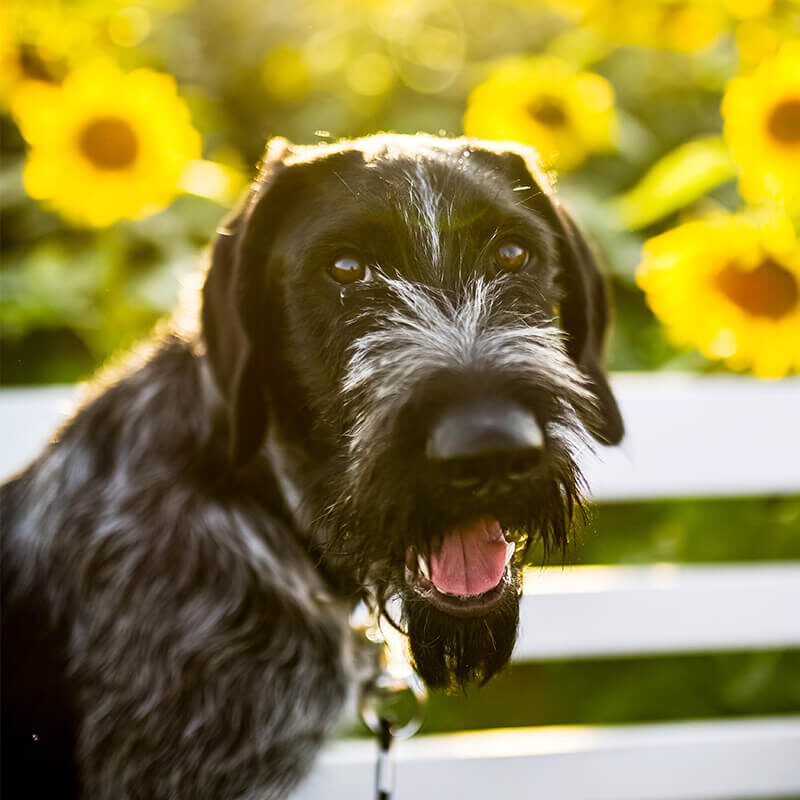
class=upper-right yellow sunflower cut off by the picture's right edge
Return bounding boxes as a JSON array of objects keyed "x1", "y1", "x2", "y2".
[{"x1": 722, "y1": 41, "x2": 800, "y2": 207}]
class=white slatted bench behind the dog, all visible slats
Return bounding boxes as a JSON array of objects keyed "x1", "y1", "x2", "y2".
[{"x1": 0, "y1": 375, "x2": 800, "y2": 800}]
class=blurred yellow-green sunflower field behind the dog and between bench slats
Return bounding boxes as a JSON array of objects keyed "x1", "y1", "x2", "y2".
[{"x1": 0, "y1": 0, "x2": 800, "y2": 731}]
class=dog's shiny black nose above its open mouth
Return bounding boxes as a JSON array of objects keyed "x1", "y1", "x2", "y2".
[{"x1": 425, "y1": 401, "x2": 545, "y2": 488}]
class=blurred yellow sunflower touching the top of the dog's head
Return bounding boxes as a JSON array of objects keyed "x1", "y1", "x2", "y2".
[{"x1": 464, "y1": 56, "x2": 617, "y2": 170}]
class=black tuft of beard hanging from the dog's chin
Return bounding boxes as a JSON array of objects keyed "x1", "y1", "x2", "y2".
[{"x1": 403, "y1": 573, "x2": 519, "y2": 690}]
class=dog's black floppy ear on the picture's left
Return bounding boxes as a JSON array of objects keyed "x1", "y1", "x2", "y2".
[{"x1": 202, "y1": 139, "x2": 296, "y2": 466}]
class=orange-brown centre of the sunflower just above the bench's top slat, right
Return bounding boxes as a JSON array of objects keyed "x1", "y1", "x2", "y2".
[{"x1": 714, "y1": 258, "x2": 800, "y2": 320}]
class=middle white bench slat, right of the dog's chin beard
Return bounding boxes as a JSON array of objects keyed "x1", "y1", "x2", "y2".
[{"x1": 514, "y1": 561, "x2": 800, "y2": 661}]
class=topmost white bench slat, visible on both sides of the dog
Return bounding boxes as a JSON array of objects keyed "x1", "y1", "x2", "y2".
[{"x1": 0, "y1": 373, "x2": 800, "y2": 501}]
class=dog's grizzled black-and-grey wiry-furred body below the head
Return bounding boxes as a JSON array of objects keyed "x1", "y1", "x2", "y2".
[{"x1": 1, "y1": 338, "x2": 351, "y2": 800}]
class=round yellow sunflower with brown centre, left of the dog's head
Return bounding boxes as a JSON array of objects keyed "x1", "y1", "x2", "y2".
[{"x1": 12, "y1": 64, "x2": 201, "y2": 227}]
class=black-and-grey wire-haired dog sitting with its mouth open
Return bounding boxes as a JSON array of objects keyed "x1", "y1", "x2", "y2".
[{"x1": 2, "y1": 134, "x2": 623, "y2": 800}]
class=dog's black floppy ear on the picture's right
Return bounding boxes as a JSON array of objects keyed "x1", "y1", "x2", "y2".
[{"x1": 473, "y1": 142, "x2": 625, "y2": 444}]
